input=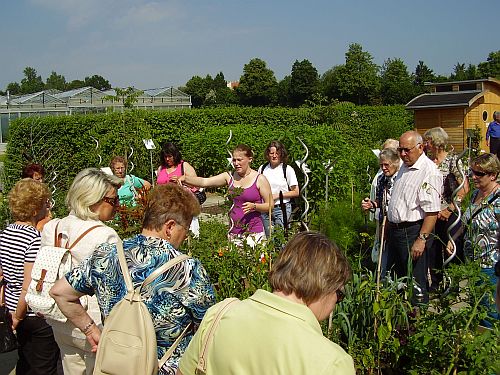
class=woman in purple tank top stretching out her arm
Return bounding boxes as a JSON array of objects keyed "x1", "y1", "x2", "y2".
[{"x1": 177, "y1": 145, "x2": 272, "y2": 246}]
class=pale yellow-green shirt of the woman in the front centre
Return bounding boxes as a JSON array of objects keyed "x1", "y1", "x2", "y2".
[{"x1": 179, "y1": 289, "x2": 356, "y2": 375}]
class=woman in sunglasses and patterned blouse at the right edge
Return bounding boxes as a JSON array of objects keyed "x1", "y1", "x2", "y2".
[{"x1": 464, "y1": 154, "x2": 500, "y2": 326}]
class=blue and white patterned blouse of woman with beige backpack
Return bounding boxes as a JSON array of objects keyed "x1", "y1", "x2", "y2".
[{"x1": 66, "y1": 234, "x2": 215, "y2": 375}]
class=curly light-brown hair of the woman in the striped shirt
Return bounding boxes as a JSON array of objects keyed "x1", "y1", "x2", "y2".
[{"x1": 8, "y1": 178, "x2": 50, "y2": 221}]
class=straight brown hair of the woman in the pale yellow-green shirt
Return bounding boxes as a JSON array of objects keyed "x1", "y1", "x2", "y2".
[{"x1": 269, "y1": 232, "x2": 351, "y2": 305}]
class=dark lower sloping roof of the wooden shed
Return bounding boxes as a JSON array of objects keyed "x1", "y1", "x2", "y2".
[{"x1": 406, "y1": 90, "x2": 487, "y2": 109}]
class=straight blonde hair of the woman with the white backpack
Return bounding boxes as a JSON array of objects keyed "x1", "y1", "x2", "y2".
[{"x1": 66, "y1": 168, "x2": 123, "y2": 220}]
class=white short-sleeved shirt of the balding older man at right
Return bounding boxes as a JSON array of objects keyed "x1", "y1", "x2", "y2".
[{"x1": 387, "y1": 154, "x2": 443, "y2": 223}]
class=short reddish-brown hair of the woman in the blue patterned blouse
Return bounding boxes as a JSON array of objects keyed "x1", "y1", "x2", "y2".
[{"x1": 142, "y1": 184, "x2": 201, "y2": 230}]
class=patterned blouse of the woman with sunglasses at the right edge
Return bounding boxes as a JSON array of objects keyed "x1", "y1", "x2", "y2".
[{"x1": 464, "y1": 188, "x2": 500, "y2": 268}]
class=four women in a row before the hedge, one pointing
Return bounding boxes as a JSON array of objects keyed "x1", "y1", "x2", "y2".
[{"x1": 110, "y1": 141, "x2": 299, "y2": 246}]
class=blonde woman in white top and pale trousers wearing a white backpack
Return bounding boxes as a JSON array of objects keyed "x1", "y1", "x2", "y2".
[{"x1": 42, "y1": 168, "x2": 122, "y2": 375}]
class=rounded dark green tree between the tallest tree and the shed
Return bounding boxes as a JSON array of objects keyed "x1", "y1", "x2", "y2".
[{"x1": 380, "y1": 58, "x2": 414, "y2": 104}]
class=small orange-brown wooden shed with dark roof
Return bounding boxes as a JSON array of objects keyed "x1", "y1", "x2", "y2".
[{"x1": 406, "y1": 78, "x2": 500, "y2": 152}]
